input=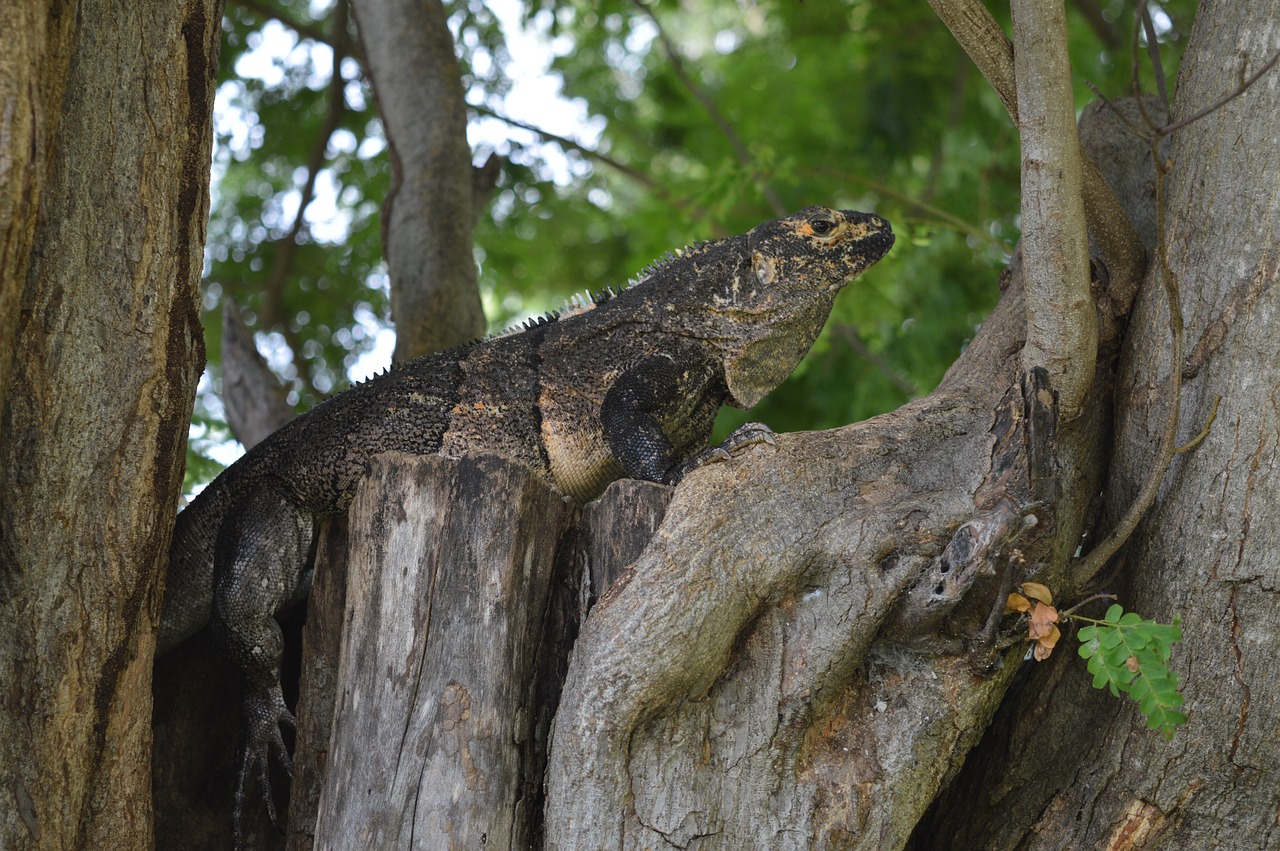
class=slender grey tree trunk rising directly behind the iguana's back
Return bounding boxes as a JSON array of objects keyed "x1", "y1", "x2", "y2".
[{"x1": 353, "y1": 0, "x2": 492, "y2": 361}]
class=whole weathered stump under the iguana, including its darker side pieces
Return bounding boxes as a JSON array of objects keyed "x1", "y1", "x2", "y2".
[{"x1": 289, "y1": 454, "x2": 671, "y2": 850}]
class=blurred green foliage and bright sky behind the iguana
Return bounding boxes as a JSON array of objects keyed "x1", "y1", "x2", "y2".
[{"x1": 188, "y1": 0, "x2": 1194, "y2": 490}]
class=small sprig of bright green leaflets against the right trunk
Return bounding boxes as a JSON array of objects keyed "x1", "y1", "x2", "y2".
[{"x1": 1073, "y1": 604, "x2": 1187, "y2": 738}]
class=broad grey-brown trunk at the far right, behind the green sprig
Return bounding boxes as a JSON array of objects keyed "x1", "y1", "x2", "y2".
[{"x1": 916, "y1": 0, "x2": 1280, "y2": 848}]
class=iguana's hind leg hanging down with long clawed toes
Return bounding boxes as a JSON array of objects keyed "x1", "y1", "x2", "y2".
[{"x1": 210, "y1": 484, "x2": 315, "y2": 848}]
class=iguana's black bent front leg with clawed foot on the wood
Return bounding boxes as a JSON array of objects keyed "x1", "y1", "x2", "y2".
[{"x1": 600, "y1": 354, "x2": 773, "y2": 485}]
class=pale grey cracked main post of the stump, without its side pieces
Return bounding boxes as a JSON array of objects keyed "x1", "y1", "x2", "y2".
[{"x1": 315, "y1": 454, "x2": 576, "y2": 850}]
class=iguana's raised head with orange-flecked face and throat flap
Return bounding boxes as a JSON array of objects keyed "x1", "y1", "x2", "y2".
[{"x1": 708, "y1": 207, "x2": 893, "y2": 408}]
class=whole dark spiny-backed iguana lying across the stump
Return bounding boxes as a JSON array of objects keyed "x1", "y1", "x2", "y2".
[{"x1": 159, "y1": 207, "x2": 893, "y2": 841}]
